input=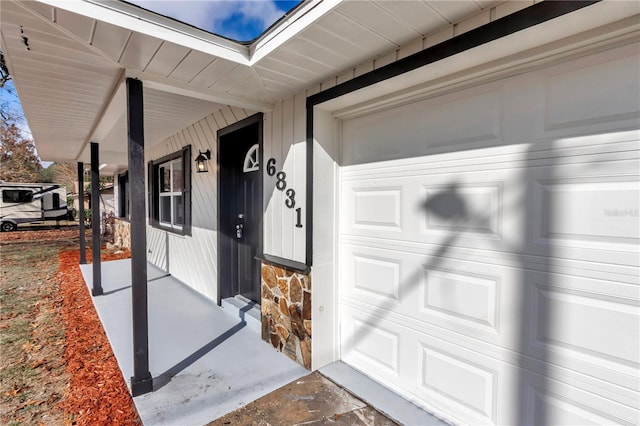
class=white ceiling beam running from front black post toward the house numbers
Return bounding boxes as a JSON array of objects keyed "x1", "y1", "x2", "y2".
[{"x1": 126, "y1": 69, "x2": 273, "y2": 112}]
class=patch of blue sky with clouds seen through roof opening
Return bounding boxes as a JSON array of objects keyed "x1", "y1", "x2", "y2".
[{"x1": 127, "y1": 0, "x2": 300, "y2": 41}]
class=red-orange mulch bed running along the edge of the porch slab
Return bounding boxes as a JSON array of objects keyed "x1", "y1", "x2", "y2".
[{"x1": 59, "y1": 250, "x2": 142, "y2": 425}]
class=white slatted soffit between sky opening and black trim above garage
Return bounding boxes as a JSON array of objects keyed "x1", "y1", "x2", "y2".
[{"x1": 251, "y1": 0, "x2": 500, "y2": 97}]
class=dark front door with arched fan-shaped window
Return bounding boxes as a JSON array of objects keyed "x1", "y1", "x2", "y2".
[{"x1": 218, "y1": 115, "x2": 262, "y2": 303}]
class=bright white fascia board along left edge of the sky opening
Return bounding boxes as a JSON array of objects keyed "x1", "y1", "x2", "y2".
[{"x1": 38, "y1": 0, "x2": 249, "y2": 65}]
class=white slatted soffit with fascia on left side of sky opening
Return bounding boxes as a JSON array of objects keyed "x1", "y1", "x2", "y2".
[{"x1": 17, "y1": 0, "x2": 274, "y2": 105}]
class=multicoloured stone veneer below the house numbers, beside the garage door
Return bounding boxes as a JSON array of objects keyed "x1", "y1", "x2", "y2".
[{"x1": 261, "y1": 263, "x2": 311, "y2": 369}]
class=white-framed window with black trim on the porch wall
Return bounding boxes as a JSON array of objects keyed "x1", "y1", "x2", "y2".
[{"x1": 149, "y1": 145, "x2": 191, "y2": 235}]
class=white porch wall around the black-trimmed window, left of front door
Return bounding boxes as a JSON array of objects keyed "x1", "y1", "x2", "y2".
[{"x1": 144, "y1": 107, "x2": 253, "y2": 300}]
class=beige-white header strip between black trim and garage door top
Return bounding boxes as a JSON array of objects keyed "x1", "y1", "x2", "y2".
[{"x1": 317, "y1": 1, "x2": 640, "y2": 119}]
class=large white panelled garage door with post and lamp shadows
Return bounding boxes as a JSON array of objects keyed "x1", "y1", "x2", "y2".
[{"x1": 339, "y1": 41, "x2": 640, "y2": 425}]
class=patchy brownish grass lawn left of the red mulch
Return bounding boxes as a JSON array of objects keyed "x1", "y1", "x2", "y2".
[{"x1": 0, "y1": 231, "x2": 77, "y2": 424}]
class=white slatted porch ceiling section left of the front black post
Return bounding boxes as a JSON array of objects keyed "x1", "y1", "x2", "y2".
[{"x1": 0, "y1": 1, "x2": 122, "y2": 161}]
